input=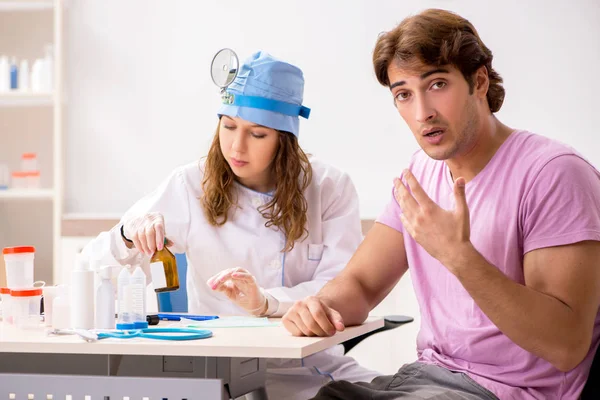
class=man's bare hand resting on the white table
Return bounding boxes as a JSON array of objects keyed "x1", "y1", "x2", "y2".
[{"x1": 282, "y1": 296, "x2": 345, "y2": 336}]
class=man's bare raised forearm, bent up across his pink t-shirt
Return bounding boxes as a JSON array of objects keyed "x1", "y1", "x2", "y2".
[{"x1": 446, "y1": 246, "x2": 589, "y2": 370}]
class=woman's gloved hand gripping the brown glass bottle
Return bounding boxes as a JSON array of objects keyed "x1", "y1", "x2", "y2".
[{"x1": 123, "y1": 212, "x2": 173, "y2": 256}]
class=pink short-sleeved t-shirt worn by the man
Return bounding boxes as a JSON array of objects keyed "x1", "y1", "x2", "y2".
[{"x1": 378, "y1": 131, "x2": 600, "y2": 400}]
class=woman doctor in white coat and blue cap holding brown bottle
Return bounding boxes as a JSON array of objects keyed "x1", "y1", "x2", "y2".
[{"x1": 84, "y1": 52, "x2": 379, "y2": 399}]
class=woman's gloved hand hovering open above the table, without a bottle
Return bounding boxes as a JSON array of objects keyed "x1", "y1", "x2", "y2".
[{"x1": 206, "y1": 268, "x2": 267, "y2": 316}]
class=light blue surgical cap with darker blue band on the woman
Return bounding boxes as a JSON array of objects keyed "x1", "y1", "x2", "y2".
[{"x1": 218, "y1": 51, "x2": 310, "y2": 137}]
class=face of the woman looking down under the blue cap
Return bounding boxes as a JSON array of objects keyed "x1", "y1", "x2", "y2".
[{"x1": 219, "y1": 115, "x2": 280, "y2": 193}]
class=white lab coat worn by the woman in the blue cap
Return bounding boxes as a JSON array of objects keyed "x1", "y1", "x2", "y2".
[{"x1": 83, "y1": 159, "x2": 380, "y2": 399}]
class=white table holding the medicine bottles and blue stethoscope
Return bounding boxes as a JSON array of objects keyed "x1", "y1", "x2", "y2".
[{"x1": 0, "y1": 317, "x2": 384, "y2": 399}]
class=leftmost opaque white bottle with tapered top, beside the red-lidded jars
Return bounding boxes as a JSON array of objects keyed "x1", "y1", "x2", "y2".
[{"x1": 71, "y1": 254, "x2": 94, "y2": 329}]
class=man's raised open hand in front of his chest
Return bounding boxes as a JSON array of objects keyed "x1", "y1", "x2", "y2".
[{"x1": 394, "y1": 170, "x2": 472, "y2": 272}]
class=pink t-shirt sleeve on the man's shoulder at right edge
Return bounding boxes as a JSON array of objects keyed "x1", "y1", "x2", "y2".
[{"x1": 521, "y1": 154, "x2": 600, "y2": 253}]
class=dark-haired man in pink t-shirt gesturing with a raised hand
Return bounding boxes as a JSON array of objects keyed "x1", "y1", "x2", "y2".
[{"x1": 284, "y1": 10, "x2": 600, "y2": 400}]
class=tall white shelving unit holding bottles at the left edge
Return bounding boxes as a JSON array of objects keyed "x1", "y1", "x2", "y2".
[{"x1": 0, "y1": 0, "x2": 62, "y2": 288}]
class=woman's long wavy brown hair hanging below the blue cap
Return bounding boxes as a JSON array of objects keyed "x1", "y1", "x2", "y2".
[{"x1": 200, "y1": 126, "x2": 312, "y2": 252}]
